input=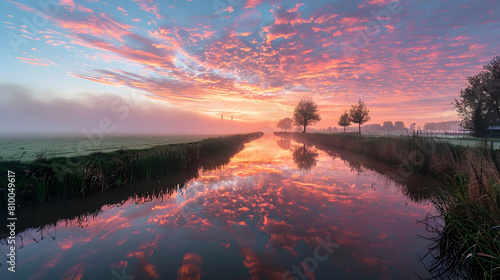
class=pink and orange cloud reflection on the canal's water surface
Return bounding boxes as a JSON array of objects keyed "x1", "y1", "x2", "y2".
[{"x1": 0, "y1": 136, "x2": 440, "y2": 280}]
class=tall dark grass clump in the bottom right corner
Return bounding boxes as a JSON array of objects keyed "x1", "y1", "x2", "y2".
[{"x1": 424, "y1": 173, "x2": 500, "y2": 279}]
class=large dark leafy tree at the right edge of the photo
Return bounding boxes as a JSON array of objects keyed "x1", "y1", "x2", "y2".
[{"x1": 454, "y1": 56, "x2": 500, "y2": 136}]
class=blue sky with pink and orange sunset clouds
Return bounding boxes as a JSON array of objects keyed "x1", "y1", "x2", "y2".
[{"x1": 0, "y1": 0, "x2": 500, "y2": 134}]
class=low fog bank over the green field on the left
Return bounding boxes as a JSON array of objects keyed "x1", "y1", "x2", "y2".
[{"x1": 0, "y1": 84, "x2": 265, "y2": 136}]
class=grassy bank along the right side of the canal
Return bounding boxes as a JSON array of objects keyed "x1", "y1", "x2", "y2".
[{"x1": 276, "y1": 133, "x2": 500, "y2": 279}]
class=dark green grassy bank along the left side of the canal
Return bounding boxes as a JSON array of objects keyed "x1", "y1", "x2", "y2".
[{"x1": 0, "y1": 132, "x2": 262, "y2": 208}]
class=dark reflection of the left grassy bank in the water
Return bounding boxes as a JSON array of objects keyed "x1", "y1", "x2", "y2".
[{"x1": 0, "y1": 139, "x2": 249, "y2": 235}]
